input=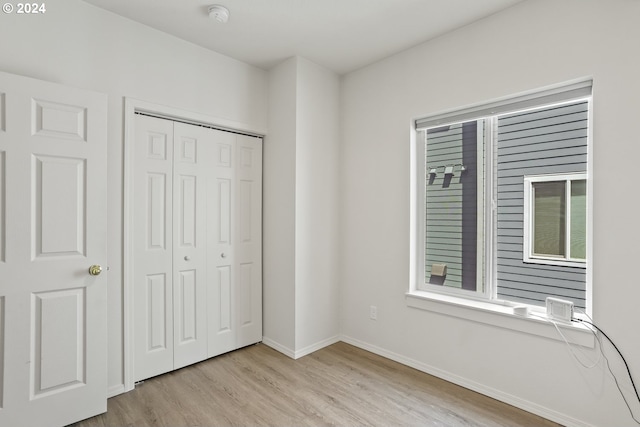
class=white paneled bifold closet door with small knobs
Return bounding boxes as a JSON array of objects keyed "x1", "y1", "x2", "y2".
[{"x1": 132, "y1": 115, "x2": 262, "y2": 381}]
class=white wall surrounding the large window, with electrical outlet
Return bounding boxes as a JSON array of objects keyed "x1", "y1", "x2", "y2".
[{"x1": 340, "y1": 0, "x2": 640, "y2": 426}]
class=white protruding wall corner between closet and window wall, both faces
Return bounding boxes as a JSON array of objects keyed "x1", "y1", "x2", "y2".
[{"x1": 263, "y1": 57, "x2": 340, "y2": 358}]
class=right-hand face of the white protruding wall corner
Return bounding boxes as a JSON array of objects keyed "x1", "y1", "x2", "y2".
[{"x1": 296, "y1": 58, "x2": 340, "y2": 354}]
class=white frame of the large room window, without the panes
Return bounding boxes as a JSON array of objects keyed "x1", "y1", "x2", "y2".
[{"x1": 407, "y1": 84, "x2": 593, "y2": 314}]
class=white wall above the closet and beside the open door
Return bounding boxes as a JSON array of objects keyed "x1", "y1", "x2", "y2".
[{"x1": 0, "y1": 0, "x2": 267, "y2": 392}]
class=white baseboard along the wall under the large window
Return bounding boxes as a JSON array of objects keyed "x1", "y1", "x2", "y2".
[{"x1": 340, "y1": 335, "x2": 595, "y2": 427}]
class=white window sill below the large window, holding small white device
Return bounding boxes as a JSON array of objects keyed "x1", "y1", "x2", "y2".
[{"x1": 406, "y1": 290, "x2": 595, "y2": 348}]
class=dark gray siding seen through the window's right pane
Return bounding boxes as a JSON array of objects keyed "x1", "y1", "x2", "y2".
[{"x1": 497, "y1": 101, "x2": 588, "y2": 308}]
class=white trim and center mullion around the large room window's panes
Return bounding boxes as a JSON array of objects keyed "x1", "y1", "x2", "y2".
[{"x1": 406, "y1": 78, "x2": 594, "y2": 317}]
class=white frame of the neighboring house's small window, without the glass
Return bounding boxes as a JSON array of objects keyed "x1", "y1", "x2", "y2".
[{"x1": 522, "y1": 173, "x2": 589, "y2": 268}]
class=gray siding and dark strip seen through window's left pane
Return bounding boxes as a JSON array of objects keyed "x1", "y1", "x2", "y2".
[{"x1": 425, "y1": 122, "x2": 477, "y2": 290}]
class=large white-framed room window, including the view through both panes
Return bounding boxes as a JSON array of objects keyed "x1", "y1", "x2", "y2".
[{"x1": 414, "y1": 82, "x2": 591, "y2": 308}]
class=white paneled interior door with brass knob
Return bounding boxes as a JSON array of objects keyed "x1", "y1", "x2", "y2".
[{"x1": 0, "y1": 69, "x2": 107, "y2": 426}]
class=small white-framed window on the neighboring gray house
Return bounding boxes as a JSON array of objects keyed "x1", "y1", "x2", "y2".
[{"x1": 523, "y1": 174, "x2": 587, "y2": 267}]
